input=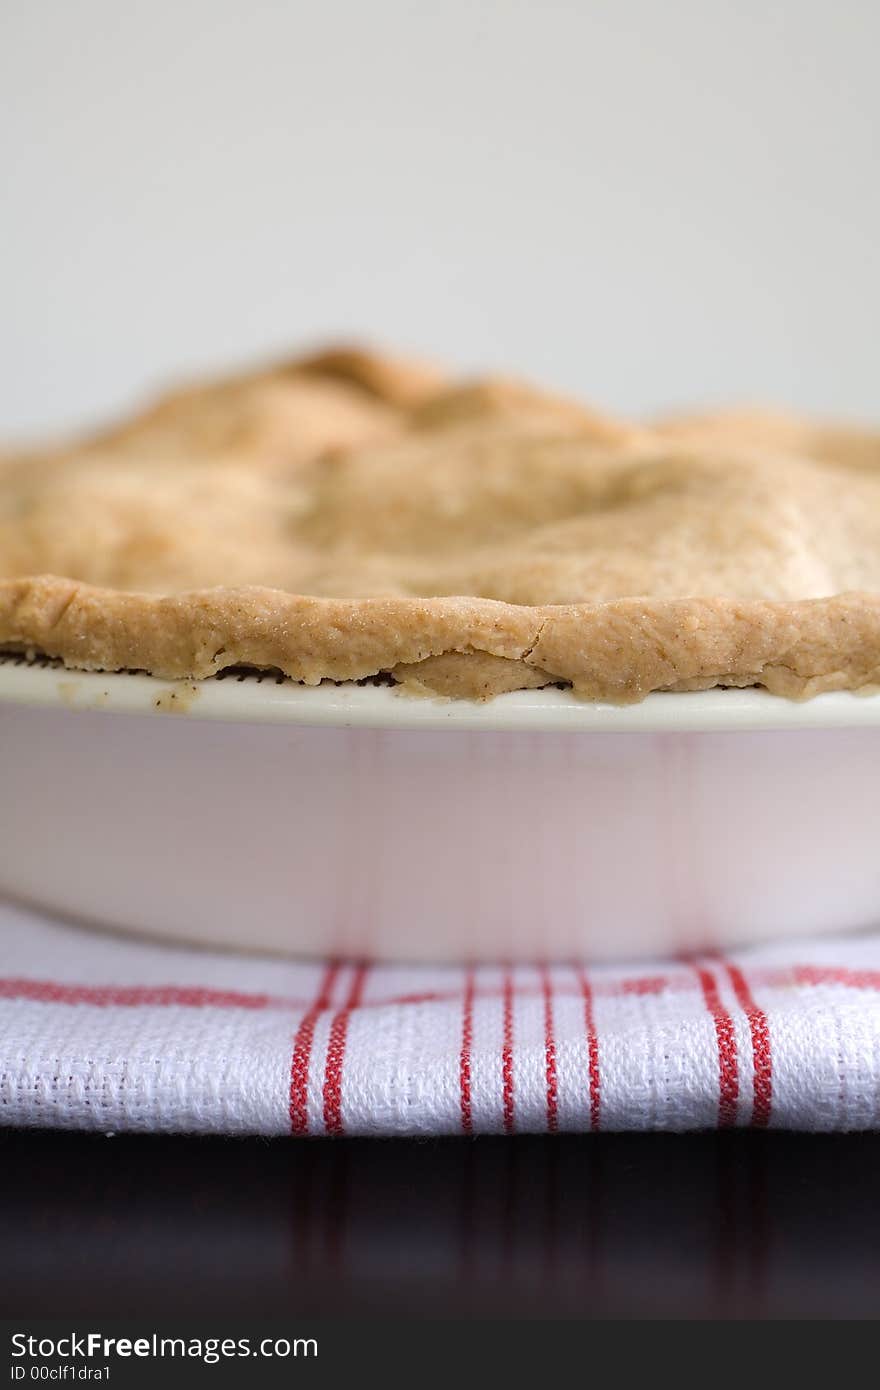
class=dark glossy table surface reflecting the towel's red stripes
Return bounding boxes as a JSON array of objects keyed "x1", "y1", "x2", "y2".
[{"x1": 0, "y1": 1130, "x2": 880, "y2": 1318}]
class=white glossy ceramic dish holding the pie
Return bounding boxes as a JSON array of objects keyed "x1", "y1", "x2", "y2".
[{"x1": 0, "y1": 656, "x2": 880, "y2": 960}]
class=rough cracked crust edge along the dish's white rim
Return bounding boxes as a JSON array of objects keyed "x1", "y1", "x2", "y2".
[{"x1": 0, "y1": 575, "x2": 880, "y2": 702}]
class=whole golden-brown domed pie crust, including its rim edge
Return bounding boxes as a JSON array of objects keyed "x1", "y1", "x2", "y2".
[{"x1": 0, "y1": 349, "x2": 880, "y2": 701}]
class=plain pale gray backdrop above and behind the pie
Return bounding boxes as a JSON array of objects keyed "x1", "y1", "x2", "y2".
[{"x1": 0, "y1": 0, "x2": 880, "y2": 436}]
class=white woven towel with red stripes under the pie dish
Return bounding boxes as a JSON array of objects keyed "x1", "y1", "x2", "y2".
[{"x1": 0, "y1": 904, "x2": 880, "y2": 1136}]
